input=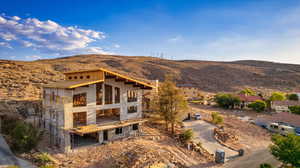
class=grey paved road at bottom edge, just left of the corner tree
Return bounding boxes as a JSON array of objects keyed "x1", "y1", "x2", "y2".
[{"x1": 224, "y1": 148, "x2": 280, "y2": 168}]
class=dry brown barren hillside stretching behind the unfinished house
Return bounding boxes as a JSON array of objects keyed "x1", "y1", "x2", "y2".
[{"x1": 0, "y1": 55, "x2": 300, "y2": 99}]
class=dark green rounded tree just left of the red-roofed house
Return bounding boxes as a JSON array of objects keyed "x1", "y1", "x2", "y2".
[{"x1": 215, "y1": 93, "x2": 241, "y2": 109}]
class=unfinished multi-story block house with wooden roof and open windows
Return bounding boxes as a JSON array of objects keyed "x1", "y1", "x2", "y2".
[{"x1": 42, "y1": 68, "x2": 155, "y2": 152}]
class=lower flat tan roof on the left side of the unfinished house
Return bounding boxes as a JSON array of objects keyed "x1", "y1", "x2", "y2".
[{"x1": 43, "y1": 80, "x2": 104, "y2": 89}]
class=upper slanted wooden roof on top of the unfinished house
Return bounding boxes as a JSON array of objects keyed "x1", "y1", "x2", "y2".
[{"x1": 64, "y1": 68, "x2": 155, "y2": 89}]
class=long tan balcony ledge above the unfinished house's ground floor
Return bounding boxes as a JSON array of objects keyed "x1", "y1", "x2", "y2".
[{"x1": 70, "y1": 119, "x2": 147, "y2": 136}]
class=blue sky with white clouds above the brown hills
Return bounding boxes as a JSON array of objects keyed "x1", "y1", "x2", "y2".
[{"x1": 0, "y1": 0, "x2": 300, "y2": 64}]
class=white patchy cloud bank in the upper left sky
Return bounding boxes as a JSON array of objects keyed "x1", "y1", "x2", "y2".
[{"x1": 0, "y1": 15, "x2": 109, "y2": 55}]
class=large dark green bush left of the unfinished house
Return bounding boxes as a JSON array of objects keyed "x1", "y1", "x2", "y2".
[{"x1": 10, "y1": 122, "x2": 39, "y2": 152}]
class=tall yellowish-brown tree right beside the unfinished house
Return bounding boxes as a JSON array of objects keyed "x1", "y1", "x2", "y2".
[{"x1": 152, "y1": 75, "x2": 188, "y2": 134}]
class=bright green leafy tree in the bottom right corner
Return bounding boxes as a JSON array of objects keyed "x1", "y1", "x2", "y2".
[{"x1": 270, "y1": 134, "x2": 300, "y2": 167}]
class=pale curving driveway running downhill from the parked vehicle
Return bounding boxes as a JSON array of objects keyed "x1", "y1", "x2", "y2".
[{"x1": 183, "y1": 120, "x2": 238, "y2": 160}]
